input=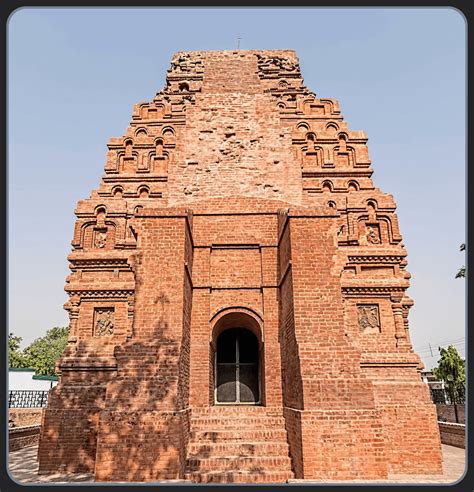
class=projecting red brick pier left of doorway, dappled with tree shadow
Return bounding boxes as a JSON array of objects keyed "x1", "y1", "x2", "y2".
[{"x1": 95, "y1": 211, "x2": 192, "y2": 481}]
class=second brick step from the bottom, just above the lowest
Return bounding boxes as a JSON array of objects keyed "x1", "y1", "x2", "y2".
[{"x1": 186, "y1": 456, "x2": 291, "y2": 473}]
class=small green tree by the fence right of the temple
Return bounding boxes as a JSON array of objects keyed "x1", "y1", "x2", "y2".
[{"x1": 433, "y1": 345, "x2": 466, "y2": 403}]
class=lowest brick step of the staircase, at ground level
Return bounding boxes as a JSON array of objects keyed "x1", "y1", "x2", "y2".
[{"x1": 185, "y1": 471, "x2": 294, "y2": 483}]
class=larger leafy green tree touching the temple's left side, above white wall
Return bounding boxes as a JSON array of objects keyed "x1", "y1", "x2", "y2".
[{"x1": 24, "y1": 326, "x2": 69, "y2": 376}]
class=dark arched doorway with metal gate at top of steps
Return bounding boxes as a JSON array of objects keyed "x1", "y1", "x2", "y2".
[{"x1": 214, "y1": 328, "x2": 260, "y2": 405}]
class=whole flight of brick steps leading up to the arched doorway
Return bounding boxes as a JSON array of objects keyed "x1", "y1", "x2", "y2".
[{"x1": 185, "y1": 406, "x2": 294, "y2": 483}]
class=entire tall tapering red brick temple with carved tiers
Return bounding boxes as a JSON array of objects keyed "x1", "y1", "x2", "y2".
[{"x1": 39, "y1": 50, "x2": 442, "y2": 483}]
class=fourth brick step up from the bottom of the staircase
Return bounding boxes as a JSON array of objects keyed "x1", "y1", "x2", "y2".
[{"x1": 189, "y1": 427, "x2": 286, "y2": 442}]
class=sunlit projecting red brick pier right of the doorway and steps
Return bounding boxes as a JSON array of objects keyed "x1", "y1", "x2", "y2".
[{"x1": 280, "y1": 209, "x2": 387, "y2": 479}]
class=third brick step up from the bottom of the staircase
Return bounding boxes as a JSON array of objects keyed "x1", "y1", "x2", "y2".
[{"x1": 188, "y1": 441, "x2": 288, "y2": 458}]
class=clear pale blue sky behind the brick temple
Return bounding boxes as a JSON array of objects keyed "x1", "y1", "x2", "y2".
[{"x1": 8, "y1": 8, "x2": 466, "y2": 368}]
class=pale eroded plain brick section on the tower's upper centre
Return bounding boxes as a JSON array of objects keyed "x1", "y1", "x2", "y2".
[{"x1": 169, "y1": 51, "x2": 302, "y2": 203}]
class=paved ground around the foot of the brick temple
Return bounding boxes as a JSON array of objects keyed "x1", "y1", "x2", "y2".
[{"x1": 8, "y1": 444, "x2": 466, "y2": 484}]
